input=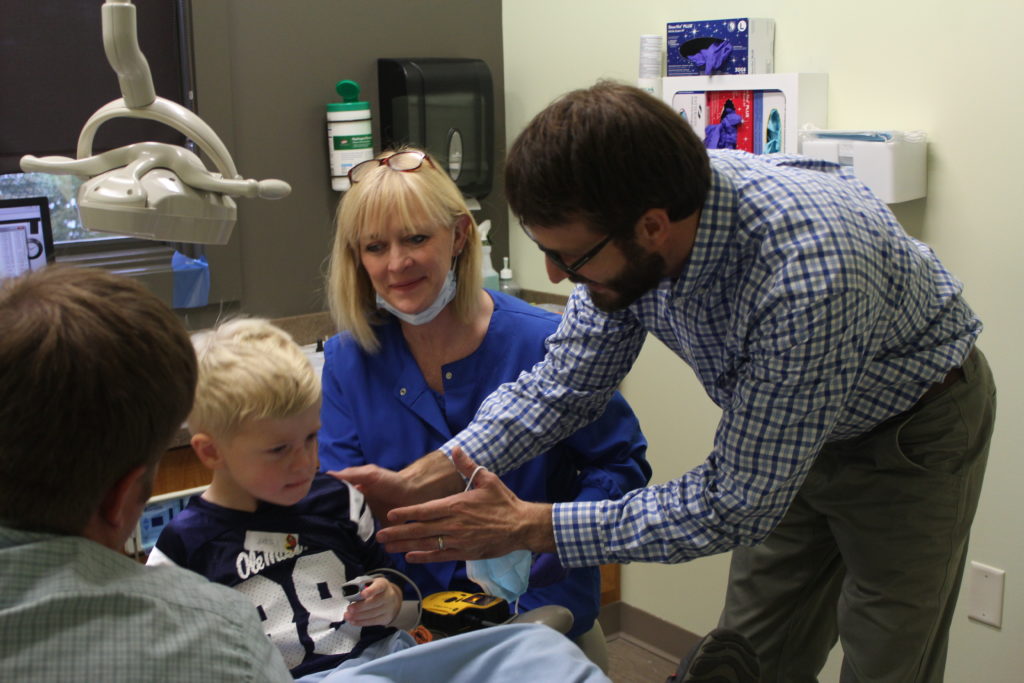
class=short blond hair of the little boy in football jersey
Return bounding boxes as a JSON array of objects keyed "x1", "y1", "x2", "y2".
[{"x1": 188, "y1": 318, "x2": 321, "y2": 438}]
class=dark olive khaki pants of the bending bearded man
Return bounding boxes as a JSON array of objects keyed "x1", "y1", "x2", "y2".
[{"x1": 721, "y1": 349, "x2": 995, "y2": 683}]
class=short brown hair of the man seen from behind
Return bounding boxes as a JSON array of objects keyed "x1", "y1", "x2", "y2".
[{"x1": 0, "y1": 265, "x2": 197, "y2": 533}]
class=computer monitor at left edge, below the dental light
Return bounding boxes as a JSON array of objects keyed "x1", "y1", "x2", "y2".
[{"x1": 0, "y1": 197, "x2": 53, "y2": 281}]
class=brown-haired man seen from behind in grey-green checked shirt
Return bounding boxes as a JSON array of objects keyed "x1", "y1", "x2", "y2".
[{"x1": 0, "y1": 264, "x2": 289, "y2": 683}]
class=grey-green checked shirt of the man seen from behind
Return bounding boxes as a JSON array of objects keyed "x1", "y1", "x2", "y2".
[{"x1": 0, "y1": 526, "x2": 292, "y2": 683}]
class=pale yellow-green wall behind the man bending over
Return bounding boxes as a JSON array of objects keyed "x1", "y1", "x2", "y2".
[{"x1": 503, "y1": 0, "x2": 1024, "y2": 681}]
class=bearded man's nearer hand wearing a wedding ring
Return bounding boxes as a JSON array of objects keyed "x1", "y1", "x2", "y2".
[{"x1": 377, "y1": 447, "x2": 555, "y2": 562}]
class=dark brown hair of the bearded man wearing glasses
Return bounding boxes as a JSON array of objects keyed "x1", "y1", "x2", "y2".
[{"x1": 505, "y1": 81, "x2": 711, "y2": 240}]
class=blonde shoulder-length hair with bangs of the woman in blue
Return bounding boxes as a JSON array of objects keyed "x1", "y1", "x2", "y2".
[{"x1": 327, "y1": 147, "x2": 482, "y2": 352}]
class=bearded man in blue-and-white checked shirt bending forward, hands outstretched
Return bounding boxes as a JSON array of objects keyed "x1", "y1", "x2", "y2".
[{"x1": 344, "y1": 83, "x2": 995, "y2": 681}]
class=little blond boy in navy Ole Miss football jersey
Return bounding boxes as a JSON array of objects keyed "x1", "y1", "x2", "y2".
[{"x1": 148, "y1": 319, "x2": 412, "y2": 677}]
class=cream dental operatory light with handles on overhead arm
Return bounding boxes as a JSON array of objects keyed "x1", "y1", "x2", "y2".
[{"x1": 20, "y1": 0, "x2": 292, "y2": 245}]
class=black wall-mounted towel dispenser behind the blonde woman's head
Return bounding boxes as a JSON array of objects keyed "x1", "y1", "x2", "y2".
[{"x1": 377, "y1": 57, "x2": 495, "y2": 199}]
